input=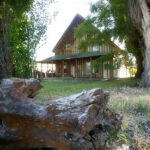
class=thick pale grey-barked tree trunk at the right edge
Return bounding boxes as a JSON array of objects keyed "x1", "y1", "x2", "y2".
[{"x1": 129, "y1": 0, "x2": 150, "y2": 86}]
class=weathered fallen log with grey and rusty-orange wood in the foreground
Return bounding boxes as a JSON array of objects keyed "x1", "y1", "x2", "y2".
[{"x1": 0, "y1": 79, "x2": 122, "y2": 150}]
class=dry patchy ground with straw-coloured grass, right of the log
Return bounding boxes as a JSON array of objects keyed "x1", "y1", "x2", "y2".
[{"x1": 109, "y1": 87, "x2": 150, "y2": 150}]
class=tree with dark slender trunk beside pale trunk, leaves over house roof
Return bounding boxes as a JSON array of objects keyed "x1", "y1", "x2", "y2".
[{"x1": 75, "y1": 0, "x2": 143, "y2": 77}]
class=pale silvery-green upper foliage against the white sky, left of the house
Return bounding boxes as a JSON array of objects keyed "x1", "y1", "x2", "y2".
[{"x1": 27, "y1": 0, "x2": 53, "y2": 50}]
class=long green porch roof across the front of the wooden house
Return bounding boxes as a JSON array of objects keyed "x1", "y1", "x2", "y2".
[{"x1": 38, "y1": 52, "x2": 104, "y2": 63}]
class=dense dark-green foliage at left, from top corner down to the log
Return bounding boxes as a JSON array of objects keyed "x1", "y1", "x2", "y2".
[{"x1": 0, "y1": 0, "x2": 33, "y2": 77}]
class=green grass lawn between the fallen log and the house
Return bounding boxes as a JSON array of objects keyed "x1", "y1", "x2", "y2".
[{"x1": 37, "y1": 78, "x2": 139, "y2": 101}]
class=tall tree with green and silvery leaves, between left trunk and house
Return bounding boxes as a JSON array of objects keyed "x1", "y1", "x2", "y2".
[{"x1": 8, "y1": 0, "x2": 51, "y2": 78}]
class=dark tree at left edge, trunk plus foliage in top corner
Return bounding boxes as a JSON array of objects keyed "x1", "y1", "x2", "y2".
[{"x1": 0, "y1": 0, "x2": 33, "y2": 79}]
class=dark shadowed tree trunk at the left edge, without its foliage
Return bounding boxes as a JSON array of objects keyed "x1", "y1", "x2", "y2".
[{"x1": 0, "y1": 2, "x2": 12, "y2": 80}]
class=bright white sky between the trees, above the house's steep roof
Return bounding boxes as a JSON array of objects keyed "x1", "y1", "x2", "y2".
[{"x1": 35, "y1": 0, "x2": 124, "y2": 60}]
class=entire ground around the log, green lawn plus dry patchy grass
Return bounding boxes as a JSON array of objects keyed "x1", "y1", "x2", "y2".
[{"x1": 36, "y1": 79, "x2": 150, "y2": 150}]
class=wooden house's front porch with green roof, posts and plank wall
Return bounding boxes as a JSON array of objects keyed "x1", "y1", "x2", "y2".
[{"x1": 36, "y1": 52, "x2": 113, "y2": 79}]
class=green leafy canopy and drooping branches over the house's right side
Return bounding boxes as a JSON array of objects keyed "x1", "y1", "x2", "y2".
[{"x1": 75, "y1": 0, "x2": 140, "y2": 71}]
